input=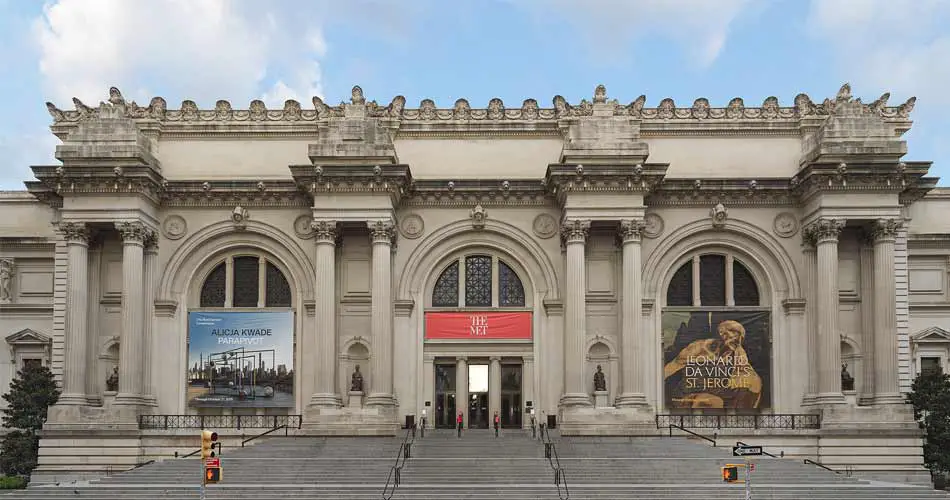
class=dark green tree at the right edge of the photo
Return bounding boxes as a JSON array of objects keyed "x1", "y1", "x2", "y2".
[{"x1": 907, "y1": 370, "x2": 950, "y2": 473}]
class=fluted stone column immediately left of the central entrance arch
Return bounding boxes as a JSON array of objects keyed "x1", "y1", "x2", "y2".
[{"x1": 366, "y1": 219, "x2": 396, "y2": 406}]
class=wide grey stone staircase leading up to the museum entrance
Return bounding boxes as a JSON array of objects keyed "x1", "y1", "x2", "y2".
[{"x1": 0, "y1": 424, "x2": 950, "y2": 500}]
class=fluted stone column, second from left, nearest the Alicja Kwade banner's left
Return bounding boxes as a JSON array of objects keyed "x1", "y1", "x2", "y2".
[{"x1": 115, "y1": 221, "x2": 152, "y2": 405}]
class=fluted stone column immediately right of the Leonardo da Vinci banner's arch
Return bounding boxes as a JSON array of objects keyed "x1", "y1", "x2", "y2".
[{"x1": 811, "y1": 219, "x2": 845, "y2": 404}]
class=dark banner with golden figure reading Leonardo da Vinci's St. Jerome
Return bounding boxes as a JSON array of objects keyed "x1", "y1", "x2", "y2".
[{"x1": 662, "y1": 311, "x2": 772, "y2": 412}]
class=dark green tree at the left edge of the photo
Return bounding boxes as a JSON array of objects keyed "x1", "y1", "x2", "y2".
[{"x1": 0, "y1": 365, "x2": 59, "y2": 475}]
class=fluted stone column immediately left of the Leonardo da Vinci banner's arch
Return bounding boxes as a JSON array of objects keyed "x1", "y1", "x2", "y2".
[{"x1": 617, "y1": 220, "x2": 647, "y2": 407}]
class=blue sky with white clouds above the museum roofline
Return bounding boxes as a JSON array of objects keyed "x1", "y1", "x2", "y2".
[{"x1": 0, "y1": 0, "x2": 950, "y2": 190}]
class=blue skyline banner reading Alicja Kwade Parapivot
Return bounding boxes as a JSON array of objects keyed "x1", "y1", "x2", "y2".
[{"x1": 187, "y1": 311, "x2": 294, "y2": 408}]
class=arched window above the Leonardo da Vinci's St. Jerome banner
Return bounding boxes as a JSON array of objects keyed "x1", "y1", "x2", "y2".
[{"x1": 666, "y1": 253, "x2": 762, "y2": 307}]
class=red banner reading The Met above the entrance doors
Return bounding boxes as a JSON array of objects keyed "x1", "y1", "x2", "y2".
[{"x1": 425, "y1": 312, "x2": 531, "y2": 340}]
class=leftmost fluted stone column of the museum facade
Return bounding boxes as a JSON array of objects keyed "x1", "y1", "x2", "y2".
[{"x1": 59, "y1": 222, "x2": 89, "y2": 405}]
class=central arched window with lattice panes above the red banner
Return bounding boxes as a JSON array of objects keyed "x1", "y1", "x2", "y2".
[{"x1": 432, "y1": 254, "x2": 525, "y2": 307}]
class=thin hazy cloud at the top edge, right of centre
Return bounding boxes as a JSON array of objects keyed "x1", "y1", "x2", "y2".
[{"x1": 510, "y1": 0, "x2": 757, "y2": 67}]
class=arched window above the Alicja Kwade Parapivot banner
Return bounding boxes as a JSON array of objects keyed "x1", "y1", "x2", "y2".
[{"x1": 198, "y1": 255, "x2": 293, "y2": 307}]
